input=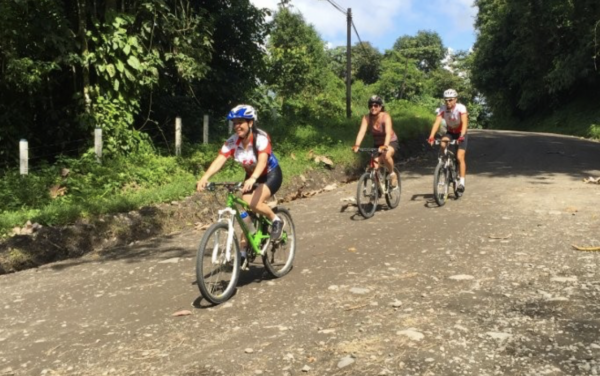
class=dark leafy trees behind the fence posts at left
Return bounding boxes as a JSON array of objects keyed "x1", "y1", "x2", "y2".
[{"x1": 0, "y1": 0, "x2": 267, "y2": 164}]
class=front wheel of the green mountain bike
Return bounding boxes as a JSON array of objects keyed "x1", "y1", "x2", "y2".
[{"x1": 196, "y1": 222, "x2": 240, "y2": 304}]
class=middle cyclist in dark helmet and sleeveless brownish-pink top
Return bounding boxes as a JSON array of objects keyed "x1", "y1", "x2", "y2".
[{"x1": 352, "y1": 95, "x2": 398, "y2": 187}]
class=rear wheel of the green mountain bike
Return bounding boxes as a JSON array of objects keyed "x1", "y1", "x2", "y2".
[{"x1": 263, "y1": 208, "x2": 296, "y2": 278}]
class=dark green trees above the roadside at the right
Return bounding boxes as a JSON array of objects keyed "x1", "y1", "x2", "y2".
[{"x1": 472, "y1": 0, "x2": 600, "y2": 118}]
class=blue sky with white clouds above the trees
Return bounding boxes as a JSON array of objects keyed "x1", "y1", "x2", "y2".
[{"x1": 250, "y1": 0, "x2": 477, "y2": 52}]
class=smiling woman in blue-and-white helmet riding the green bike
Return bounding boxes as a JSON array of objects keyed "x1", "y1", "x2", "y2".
[{"x1": 196, "y1": 104, "x2": 283, "y2": 239}]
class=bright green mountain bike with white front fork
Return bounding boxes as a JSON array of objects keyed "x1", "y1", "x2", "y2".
[{"x1": 196, "y1": 183, "x2": 296, "y2": 304}]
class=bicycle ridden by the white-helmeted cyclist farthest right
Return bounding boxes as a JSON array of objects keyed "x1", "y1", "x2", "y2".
[{"x1": 433, "y1": 140, "x2": 461, "y2": 206}]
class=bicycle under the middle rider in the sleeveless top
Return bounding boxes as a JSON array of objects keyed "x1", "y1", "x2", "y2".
[{"x1": 356, "y1": 148, "x2": 402, "y2": 218}]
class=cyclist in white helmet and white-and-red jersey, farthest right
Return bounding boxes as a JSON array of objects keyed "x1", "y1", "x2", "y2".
[{"x1": 427, "y1": 89, "x2": 469, "y2": 194}]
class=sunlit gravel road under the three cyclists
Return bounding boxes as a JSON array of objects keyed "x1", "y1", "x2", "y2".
[{"x1": 0, "y1": 131, "x2": 600, "y2": 376}]
